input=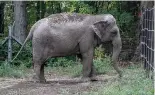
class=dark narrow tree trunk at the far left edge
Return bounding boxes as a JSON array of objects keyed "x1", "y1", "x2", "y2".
[{"x1": 0, "y1": 1, "x2": 5, "y2": 34}]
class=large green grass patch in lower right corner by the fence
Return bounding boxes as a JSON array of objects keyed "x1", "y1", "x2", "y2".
[{"x1": 82, "y1": 67, "x2": 154, "y2": 95}]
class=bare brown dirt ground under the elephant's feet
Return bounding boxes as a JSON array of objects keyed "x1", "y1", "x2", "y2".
[{"x1": 0, "y1": 74, "x2": 117, "y2": 95}]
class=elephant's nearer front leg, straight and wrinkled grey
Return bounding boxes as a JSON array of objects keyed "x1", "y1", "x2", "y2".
[{"x1": 82, "y1": 49, "x2": 95, "y2": 79}]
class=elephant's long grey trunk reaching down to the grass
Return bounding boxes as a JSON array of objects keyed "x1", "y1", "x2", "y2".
[{"x1": 112, "y1": 37, "x2": 122, "y2": 77}]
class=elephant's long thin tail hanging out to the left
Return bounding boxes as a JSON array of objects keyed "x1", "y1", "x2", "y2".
[{"x1": 11, "y1": 24, "x2": 36, "y2": 62}]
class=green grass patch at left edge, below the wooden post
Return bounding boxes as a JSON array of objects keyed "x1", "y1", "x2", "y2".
[{"x1": 0, "y1": 62, "x2": 26, "y2": 78}]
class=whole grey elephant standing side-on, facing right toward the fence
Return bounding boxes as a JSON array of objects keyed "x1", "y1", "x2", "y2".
[{"x1": 13, "y1": 13, "x2": 122, "y2": 82}]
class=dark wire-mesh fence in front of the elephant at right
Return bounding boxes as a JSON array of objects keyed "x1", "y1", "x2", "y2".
[{"x1": 141, "y1": 8, "x2": 155, "y2": 77}]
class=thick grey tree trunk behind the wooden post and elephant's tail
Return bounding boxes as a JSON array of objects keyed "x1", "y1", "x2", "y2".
[{"x1": 13, "y1": 1, "x2": 27, "y2": 43}]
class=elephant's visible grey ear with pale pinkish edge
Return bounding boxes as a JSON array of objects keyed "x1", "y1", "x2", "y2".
[{"x1": 92, "y1": 21, "x2": 107, "y2": 39}]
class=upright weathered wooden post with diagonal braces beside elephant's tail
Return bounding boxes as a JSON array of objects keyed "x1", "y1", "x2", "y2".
[{"x1": 8, "y1": 26, "x2": 12, "y2": 62}]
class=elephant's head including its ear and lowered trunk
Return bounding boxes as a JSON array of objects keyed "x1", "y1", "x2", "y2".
[{"x1": 86, "y1": 14, "x2": 122, "y2": 77}]
